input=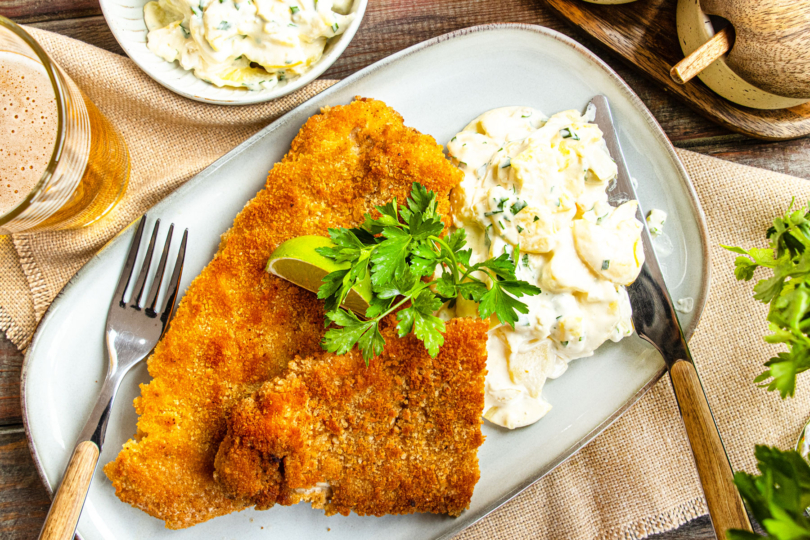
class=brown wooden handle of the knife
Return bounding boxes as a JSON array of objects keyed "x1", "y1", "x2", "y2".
[{"x1": 669, "y1": 360, "x2": 751, "y2": 540}]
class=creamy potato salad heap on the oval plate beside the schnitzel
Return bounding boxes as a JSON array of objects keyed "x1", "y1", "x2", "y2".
[{"x1": 447, "y1": 107, "x2": 644, "y2": 428}]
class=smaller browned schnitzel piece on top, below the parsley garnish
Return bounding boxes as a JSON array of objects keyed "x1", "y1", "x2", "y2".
[{"x1": 216, "y1": 316, "x2": 489, "y2": 516}]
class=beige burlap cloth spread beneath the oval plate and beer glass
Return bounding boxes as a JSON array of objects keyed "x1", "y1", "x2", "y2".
[{"x1": 0, "y1": 29, "x2": 810, "y2": 540}]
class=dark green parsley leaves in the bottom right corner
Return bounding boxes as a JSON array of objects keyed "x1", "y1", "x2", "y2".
[{"x1": 728, "y1": 446, "x2": 810, "y2": 540}]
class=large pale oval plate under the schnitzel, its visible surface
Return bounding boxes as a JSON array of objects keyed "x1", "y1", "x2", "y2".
[{"x1": 23, "y1": 25, "x2": 709, "y2": 540}]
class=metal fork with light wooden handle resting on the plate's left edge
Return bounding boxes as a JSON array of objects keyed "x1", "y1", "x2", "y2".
[{"x1": 39, "y1": 215, "x2": 188, "y2": 540}]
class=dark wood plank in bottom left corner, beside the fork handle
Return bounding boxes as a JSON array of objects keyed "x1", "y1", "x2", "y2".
[{"x1": 0, "y1": 427, "x2": 51, "y2": 540}]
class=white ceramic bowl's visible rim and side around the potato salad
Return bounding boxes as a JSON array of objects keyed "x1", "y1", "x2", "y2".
[{"x1": 100, "y1": 0, "x2": 368, "y2": 105}]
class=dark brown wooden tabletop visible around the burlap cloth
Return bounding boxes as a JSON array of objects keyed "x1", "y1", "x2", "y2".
[{"x1": 0, "y1": 0, "x2": 810, "y2": 540}]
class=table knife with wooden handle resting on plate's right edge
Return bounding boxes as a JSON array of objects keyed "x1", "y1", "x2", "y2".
[{"x1": 589, "y1": 96, "x2": 751, "y2": 540}]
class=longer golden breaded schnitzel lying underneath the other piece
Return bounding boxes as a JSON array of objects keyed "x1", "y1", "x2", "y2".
[{"x1": 104, "y1": 100, "x2": 461, "y2": 529}]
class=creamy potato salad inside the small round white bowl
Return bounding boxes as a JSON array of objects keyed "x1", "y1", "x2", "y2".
[{"x1": 144, "y1": 0, "x2": 354, "y2": 90}]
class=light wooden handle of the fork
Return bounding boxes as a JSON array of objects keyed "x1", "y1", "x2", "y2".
[{"x1": 39, "y1": 441, "x2": 99, "y2": 540}]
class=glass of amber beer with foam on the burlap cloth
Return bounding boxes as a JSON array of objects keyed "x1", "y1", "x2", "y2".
[{"x1": 0, "y1": 16, "x2": 129, "y2": 234}]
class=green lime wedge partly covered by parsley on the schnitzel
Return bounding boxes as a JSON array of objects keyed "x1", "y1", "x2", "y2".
[{"x1": 265, "y1": 236, "x2": 371, "y2": 315}]
